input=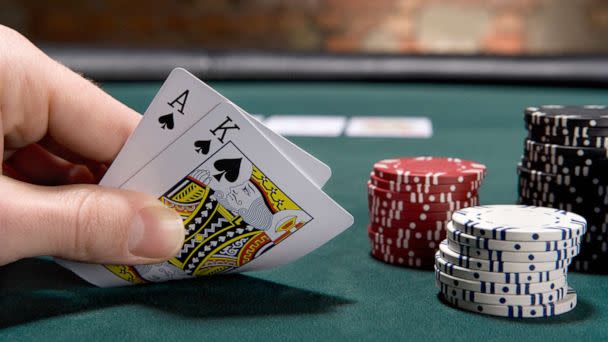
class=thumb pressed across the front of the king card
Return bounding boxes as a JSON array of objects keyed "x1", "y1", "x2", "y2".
[{"x1": 0, "y1": 176, "x2": 184, "y2": 265}]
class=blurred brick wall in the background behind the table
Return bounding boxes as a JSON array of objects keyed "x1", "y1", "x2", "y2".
[{"x1": 0, "y1": 0, "x2": 608, "y2": 54}]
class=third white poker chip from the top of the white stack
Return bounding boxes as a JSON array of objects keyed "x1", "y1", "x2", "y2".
[{"x1": 447, "y1": 238, "x2": 580, "y2": 262}]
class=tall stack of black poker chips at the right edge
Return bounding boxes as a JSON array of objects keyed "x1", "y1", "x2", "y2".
[{"x1": 517, "y1": 105, "x2": 608, "y2": 273}]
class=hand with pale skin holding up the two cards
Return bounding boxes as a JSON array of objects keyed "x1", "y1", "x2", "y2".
[{"x1": 0, "y1": 25, "x2": 184, "y2": 265}]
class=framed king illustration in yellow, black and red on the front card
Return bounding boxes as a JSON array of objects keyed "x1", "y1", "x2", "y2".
[{"x1": 105, "y1": 143, "x2": 313, "y2": 283}]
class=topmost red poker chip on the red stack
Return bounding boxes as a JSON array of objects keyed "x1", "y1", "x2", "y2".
[{"x1": 373, "y1": 157, "x2": 486, "y2": 185}]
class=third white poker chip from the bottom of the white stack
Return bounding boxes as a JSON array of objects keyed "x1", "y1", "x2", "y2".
[{"x1": 434, "y1": 266, "x2": 568, "y2": 295}]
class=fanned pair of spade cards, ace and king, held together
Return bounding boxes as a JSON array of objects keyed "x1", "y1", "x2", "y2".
[{"x1": 57, "y1": 69, "x2": 353, "y2": 286}]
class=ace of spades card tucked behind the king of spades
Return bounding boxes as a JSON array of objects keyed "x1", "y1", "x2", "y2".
[{"x1": 100, "y1": 68, "x2": 331, "y2": 187}]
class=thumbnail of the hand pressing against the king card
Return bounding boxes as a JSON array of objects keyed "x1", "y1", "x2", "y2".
[{"x1": 129, "y1": 205, "x2": 184, "y2": 259}]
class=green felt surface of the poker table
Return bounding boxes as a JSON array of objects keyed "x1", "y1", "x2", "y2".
[{"x1": 0, "y1": 82, "x2": 608, "y2": 341}]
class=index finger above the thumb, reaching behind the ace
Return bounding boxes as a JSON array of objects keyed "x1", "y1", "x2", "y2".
[{"x1": 0, "y1": 26, "x2": 141, "y2": 162}]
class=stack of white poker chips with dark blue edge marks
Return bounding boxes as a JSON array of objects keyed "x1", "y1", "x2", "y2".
[{"x1": 435, "y1": 205, "x2": 587, "y2": 318}]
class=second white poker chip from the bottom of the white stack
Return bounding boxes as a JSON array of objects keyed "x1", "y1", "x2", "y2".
[{"x1": 435, "y1": 280, "x2": 568, "y2": 305}]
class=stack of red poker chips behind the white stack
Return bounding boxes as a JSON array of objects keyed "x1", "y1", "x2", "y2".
[{"x1": 367, "y1": 157, "x2": 486, "y2": 269}]
